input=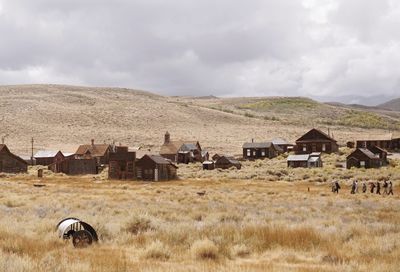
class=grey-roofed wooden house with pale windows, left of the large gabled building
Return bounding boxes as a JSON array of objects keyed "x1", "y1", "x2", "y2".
[{"x1": 242, "y1": 141, "x2": 280, "y2": 160}]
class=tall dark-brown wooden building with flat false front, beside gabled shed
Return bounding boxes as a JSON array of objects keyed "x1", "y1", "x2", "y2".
[{"x1": 108, "y1": 146, "x2": 136, "y2": 180}]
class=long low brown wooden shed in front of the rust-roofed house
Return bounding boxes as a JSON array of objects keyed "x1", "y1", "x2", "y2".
[{"x1": 48, "y1": 155, "x2": 98, "y2": 176}]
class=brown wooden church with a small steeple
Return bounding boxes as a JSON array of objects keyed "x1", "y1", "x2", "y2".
[{"x1": 160, "y1": 131, "x2": 203, "y2": 164}]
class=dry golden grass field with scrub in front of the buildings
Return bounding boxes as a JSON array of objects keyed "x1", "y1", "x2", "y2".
[{"x1": 0, "y1": 160, "x2": 400, "y2": 271}]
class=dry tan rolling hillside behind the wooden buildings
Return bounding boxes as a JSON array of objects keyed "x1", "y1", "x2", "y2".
[{"x1": 0, "y1": 85, "x2": 400, "y2": 155}]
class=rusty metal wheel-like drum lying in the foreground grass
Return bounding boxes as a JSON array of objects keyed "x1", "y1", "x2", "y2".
[{"x1": 57, "y1": 217, "x2": 98, "y2": 248}]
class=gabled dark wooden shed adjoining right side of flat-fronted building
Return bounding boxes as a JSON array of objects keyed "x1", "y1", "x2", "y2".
[{"x1": 136, "y1": 155, "x2": 178, "y2": 181}]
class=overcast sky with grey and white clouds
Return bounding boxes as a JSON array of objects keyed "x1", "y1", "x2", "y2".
[{"x1": 0, "y1": 0, "x2": 400, "y2": 101}]
